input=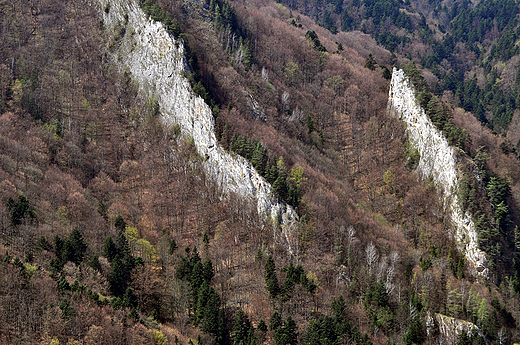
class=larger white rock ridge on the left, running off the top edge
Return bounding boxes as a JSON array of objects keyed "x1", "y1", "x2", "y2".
[{"x1": 98, "y1": 0, "x2": 298, "y2": 247}]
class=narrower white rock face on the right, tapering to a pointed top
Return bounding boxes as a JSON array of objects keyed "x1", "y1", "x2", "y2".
[{"x1": 388, "y1": 68, "x2": 488, "y2": 276}]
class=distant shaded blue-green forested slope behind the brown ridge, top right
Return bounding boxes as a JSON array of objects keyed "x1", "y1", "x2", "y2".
[{"x1": 274, "y1": 0, "x2": 520, "y2": 137}]
